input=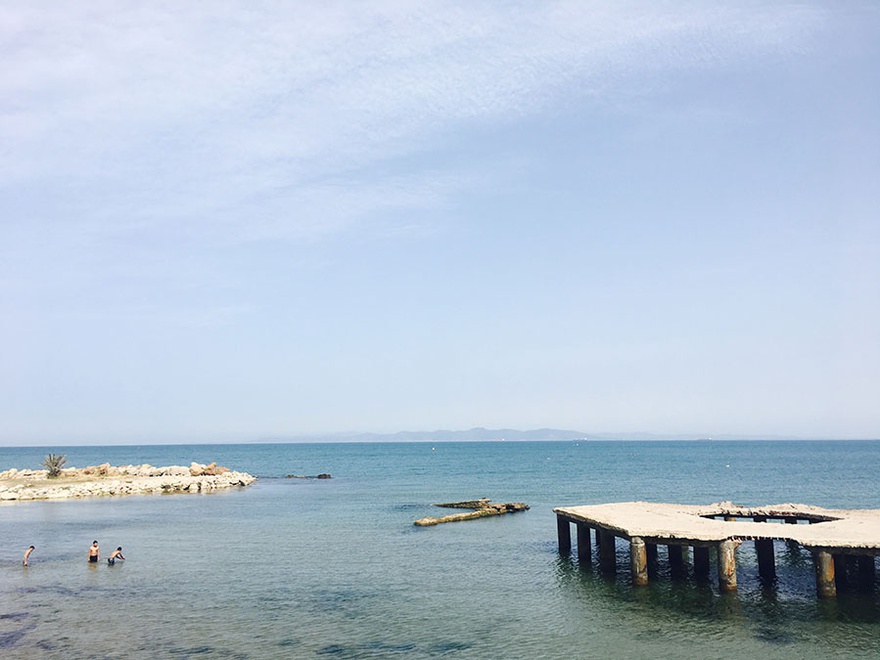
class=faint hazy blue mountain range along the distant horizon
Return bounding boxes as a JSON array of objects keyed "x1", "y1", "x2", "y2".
[{"x1": 255, "y1": 427, "x2": 796, "y2": 442}]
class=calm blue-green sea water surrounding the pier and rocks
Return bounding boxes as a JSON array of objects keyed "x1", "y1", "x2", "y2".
[{"x1": 0, "y1": 441, "x2": 880, "y2": 658}]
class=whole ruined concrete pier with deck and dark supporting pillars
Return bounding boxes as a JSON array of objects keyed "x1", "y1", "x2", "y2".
[{"x1": 553, "y1": 502, "x2": 880, "y2": 598}]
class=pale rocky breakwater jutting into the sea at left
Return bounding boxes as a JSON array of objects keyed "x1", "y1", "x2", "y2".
[{"x1": 0, "y1": 463, "x2": 257, "y2": 501}]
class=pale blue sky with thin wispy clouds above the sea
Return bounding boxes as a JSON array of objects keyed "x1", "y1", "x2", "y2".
[{"x1": 0, "y1": 0, "x2": 880, "y2": 445}]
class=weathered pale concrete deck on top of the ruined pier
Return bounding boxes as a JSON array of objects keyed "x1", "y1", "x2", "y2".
[{"x1": 554, "y1": 502, "x2": 880, "y2": 554}]
